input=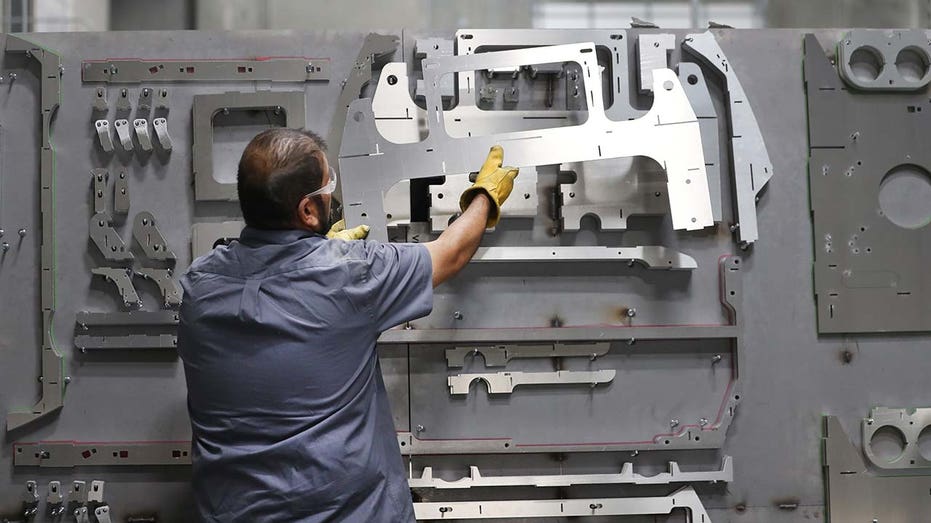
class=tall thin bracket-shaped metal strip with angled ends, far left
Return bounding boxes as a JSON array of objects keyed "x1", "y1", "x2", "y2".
[{"x1": 6, "y1": 35, "x2": 65, "y2": 431}]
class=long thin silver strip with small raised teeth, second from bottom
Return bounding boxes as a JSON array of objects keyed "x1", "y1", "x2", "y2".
[{"x1": 407, "y1": 456, "x2": 734, "y2": 489}]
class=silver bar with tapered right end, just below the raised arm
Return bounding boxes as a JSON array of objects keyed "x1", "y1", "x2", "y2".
[{"x1": 472, "y1": 246, "x2": 698, "y2": 270}]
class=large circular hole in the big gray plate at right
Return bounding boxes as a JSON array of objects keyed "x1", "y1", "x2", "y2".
[{"x1": 879, "y1": 164, "x2": 931, "y2": 229}]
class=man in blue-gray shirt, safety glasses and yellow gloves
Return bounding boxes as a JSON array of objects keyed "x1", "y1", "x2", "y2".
[{"x1": 178, "y1": 129, "x2": 518, "y2": 523}]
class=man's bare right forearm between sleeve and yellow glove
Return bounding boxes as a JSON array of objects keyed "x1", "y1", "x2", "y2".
[{"x1": 426, "y1": 193, "x2": 491, "y2": 287}]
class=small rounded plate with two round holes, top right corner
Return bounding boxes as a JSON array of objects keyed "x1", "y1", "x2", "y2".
[{"x1": 837, "y1": 29, "x2": 931, "y2": 91}]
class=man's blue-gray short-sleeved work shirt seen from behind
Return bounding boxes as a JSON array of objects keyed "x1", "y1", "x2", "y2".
[{"x1": 178, "y1": 228, "x2": 432, "y2": 522}]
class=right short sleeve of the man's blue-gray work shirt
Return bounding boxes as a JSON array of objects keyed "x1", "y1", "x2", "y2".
[{"x1": 366, "y1": 242, "x2": 433, "y2": 332}]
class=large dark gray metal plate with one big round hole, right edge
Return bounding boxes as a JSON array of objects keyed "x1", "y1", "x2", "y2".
[{"x1": 804, "y1": 35, "x2": 931, "y2": 334}]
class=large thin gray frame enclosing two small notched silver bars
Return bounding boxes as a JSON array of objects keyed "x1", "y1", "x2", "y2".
[{"x1": 392, "y1": 256, "x2": 743, "y2": 455}]
